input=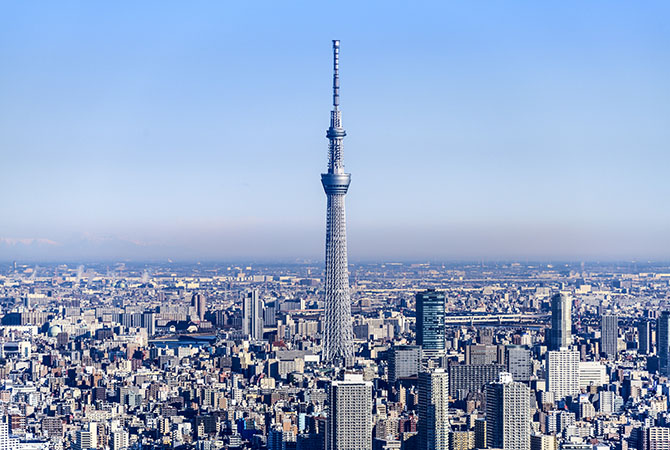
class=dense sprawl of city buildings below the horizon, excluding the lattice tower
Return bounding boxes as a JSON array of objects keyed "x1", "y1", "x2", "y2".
[{"x1": 0, "y1": 263, "x2": 670, "y2": 450}]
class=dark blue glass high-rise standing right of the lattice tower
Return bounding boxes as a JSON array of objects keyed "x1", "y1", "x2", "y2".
[{"x1": 416, "y1": 289, "x2": 445, "y2": 355}]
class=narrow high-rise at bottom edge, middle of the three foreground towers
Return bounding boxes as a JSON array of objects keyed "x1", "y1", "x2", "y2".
[{"x1": 418, "y1": 369, "x2": 449, "y2": 450}]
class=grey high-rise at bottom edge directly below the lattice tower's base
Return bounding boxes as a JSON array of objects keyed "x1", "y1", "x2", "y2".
[{"x1": 326, "y1": 374, "x2": 372, "y2": 450}]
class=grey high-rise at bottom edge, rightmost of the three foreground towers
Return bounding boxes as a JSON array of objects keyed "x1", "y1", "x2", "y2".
[{"x1": 486, "y1": 373, "x2": 531, "y2": 450}]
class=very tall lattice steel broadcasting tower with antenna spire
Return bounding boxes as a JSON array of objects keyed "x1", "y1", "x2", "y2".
[{"x1": 321, "y1": 41, "x2": 354, "y2": 365}]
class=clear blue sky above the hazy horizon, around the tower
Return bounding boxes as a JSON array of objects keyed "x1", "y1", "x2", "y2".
[{"x1": 0, "y1": 1, "x2": 670, "y2": 260}]
